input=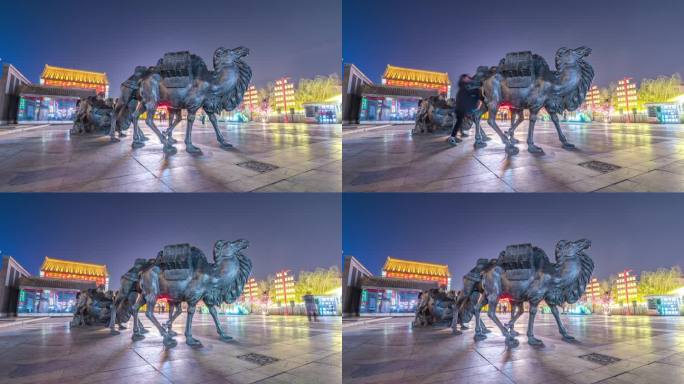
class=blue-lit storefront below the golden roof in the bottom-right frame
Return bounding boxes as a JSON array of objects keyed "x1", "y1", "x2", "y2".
[{"x1": 359, "y1": 276, "x2": 439, "y2": 316}]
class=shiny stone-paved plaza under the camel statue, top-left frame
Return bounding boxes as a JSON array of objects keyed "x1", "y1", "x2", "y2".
[{"x1": 0, "y1": 121, "x2": 342, "y2": 192}]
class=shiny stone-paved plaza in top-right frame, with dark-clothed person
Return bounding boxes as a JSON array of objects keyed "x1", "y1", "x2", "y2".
[{"x1": 342, "y1": 121, "x2": 684, "y2": 192}]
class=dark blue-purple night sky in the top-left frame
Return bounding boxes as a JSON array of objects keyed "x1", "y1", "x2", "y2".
[{"x1": 0, "y1": 0, "x2": 341, "y2": 96}]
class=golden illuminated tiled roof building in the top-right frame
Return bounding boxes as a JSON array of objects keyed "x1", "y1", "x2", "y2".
[{"x1": 382, "y1": 64, "x2": 451, "y2": 98}]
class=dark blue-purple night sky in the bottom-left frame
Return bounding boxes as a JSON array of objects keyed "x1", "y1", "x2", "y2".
[{"x1": 0, "y1": 193, "x2": 341, "y2": 288}]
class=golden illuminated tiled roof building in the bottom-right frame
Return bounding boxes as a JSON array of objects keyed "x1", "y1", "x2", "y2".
[{"x1": 382, "y1": 257, "x2": 451, "y2": 291}]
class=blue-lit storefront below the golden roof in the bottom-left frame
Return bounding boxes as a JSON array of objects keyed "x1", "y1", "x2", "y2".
[{"x1": 17, "y1": 277, "x2": 96, "y2": 316}]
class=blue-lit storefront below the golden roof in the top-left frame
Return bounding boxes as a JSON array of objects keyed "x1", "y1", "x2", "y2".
[{"x1": 17, "y1": 84, "x2": 95, "y2": 123}]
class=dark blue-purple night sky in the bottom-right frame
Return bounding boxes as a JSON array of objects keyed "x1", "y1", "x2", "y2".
[{"x1": 342, "y1": 193, "x2": 684, "y2": 285}]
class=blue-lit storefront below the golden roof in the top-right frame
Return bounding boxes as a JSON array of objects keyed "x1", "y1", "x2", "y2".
[{"x1": 359, "y1": 84, "x2": 438, "y2": 123}]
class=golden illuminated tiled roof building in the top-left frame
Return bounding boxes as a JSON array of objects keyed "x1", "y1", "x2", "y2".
[{"x1": 40, "y1": 64, "x2": 109, "y2": 98}]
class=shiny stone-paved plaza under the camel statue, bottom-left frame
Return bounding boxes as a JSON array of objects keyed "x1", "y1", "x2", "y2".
[{"x1": 0, "y1": 315, "x2": 342, "y2": 384}]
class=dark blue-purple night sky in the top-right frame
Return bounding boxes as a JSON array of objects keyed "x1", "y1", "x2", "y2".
[{"x1": 342, "y1": 0, "x2": 684, "y2": 86}]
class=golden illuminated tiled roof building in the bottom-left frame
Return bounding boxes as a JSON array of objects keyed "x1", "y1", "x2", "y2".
[{"x1": 40, "y1": 256, "x2": 109, "y2": 290}]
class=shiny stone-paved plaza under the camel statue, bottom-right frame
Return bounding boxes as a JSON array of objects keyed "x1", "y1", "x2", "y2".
[{"x1": 342, "y1": 314, "x2": 684, "y2": 384}]
